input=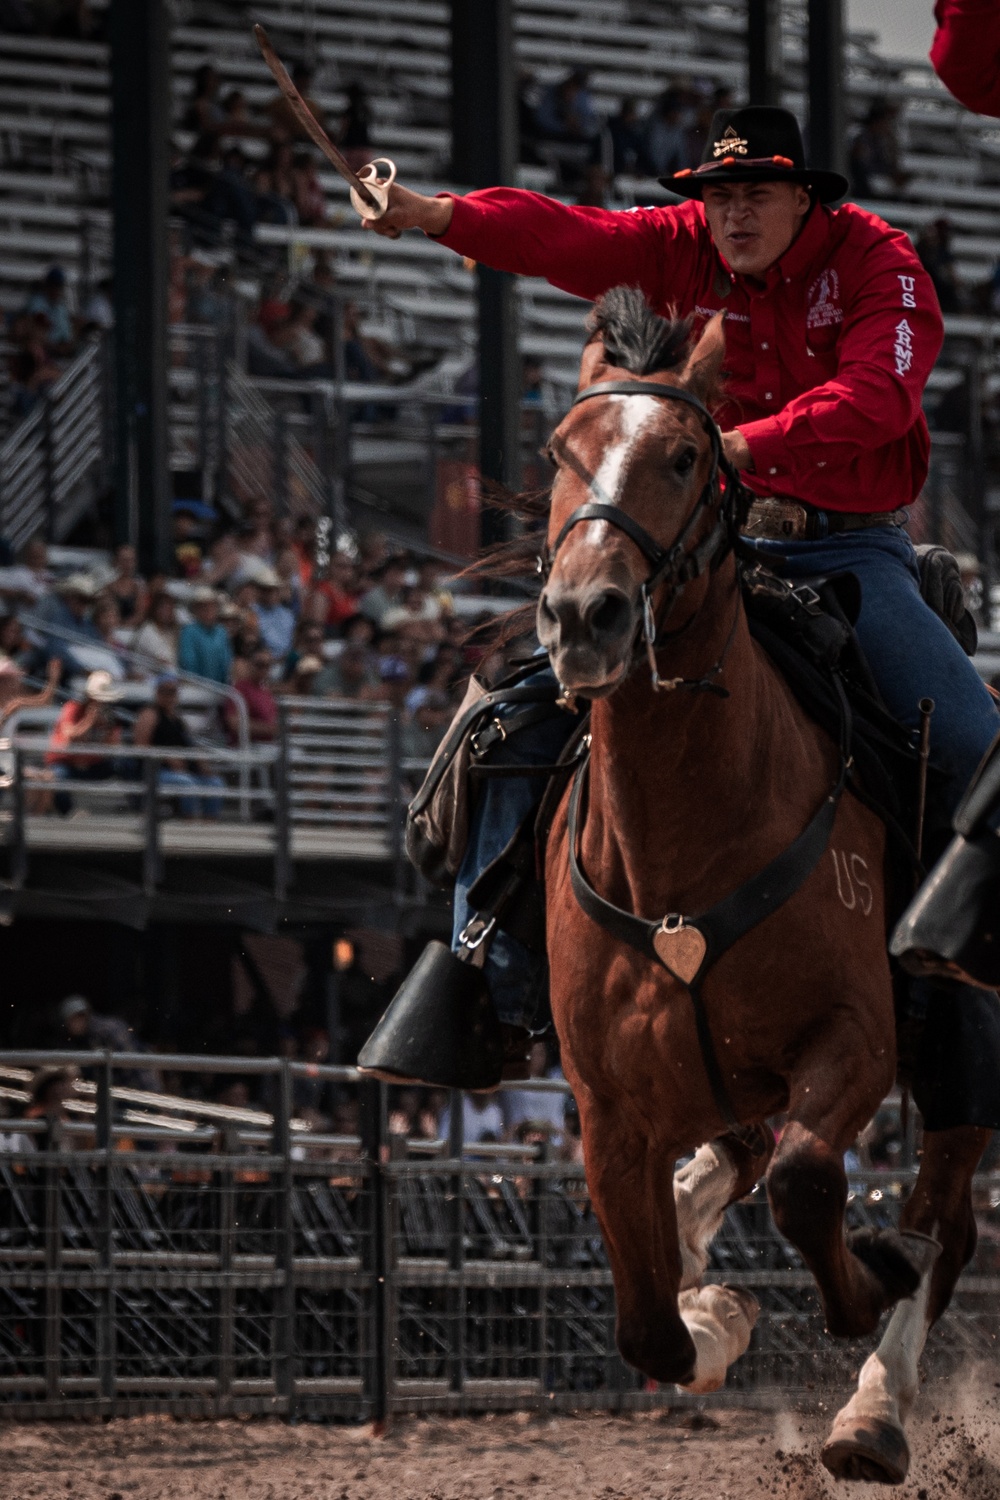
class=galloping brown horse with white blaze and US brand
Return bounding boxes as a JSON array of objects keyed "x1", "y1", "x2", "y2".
[{"x1": 538, "y1": 288, "x2": 988, "y2": 1482}]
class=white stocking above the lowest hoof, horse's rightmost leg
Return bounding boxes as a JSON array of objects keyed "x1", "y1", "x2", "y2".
[{"x1": 835, "y1": 1227, "x2": 940, "y2": 1431}]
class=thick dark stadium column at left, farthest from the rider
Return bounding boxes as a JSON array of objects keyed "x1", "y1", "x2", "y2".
[{"x1": 109, "y1": 0, "x2": 171, "y2": 573}]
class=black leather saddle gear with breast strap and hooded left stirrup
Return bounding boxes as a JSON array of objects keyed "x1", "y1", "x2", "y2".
[{"x1": 358, "y1": 558, "x2": 971, "y2": 1092}]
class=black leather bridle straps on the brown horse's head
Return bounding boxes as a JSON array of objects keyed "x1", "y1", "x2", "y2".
[{"x1": 537, "y1": 380, "x2": 753, "y2": 693}]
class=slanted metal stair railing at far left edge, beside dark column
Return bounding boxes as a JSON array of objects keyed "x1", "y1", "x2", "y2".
[{"x1": 0, "y1": 339, "x2": 109, "y2": 548}]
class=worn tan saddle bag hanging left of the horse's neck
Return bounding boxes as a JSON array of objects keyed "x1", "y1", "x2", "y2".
[{"x1": 405, "y1": 659, "x2": 559, "y2": 890}]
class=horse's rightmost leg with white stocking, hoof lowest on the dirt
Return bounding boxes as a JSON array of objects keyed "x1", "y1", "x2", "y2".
[{"x1": 823, "y1": 1127, "x2": 990, "y2": 1484}]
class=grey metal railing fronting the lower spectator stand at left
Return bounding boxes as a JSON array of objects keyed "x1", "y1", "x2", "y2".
[{"x1": 0, "y1": 698, "x2": 410, "y2": 882}]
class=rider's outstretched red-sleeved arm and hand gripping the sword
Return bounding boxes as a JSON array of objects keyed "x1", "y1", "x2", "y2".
[{"x1": 364, "y1": 185, "x2": 705, "y2": 308}]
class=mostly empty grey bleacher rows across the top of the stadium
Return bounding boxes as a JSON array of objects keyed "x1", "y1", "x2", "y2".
[{"x1": 0, "y1": 0, "x2": 1000, "y2": 528}]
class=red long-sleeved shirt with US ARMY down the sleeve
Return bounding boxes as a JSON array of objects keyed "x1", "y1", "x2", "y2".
[{"x1": 441, "y1": 188, "x2": 943, "y2": 512}]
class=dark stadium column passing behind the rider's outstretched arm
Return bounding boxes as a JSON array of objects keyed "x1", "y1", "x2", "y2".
[{"x1": 451, "y1": 0, "x2": 520, "y2": 542}]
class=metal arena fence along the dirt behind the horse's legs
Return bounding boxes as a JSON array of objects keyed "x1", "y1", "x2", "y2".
[{"x1": 0, "y1": 1053, "x2": 1000, "y2": 1421}]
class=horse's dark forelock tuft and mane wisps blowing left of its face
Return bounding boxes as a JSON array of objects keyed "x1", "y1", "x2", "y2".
[{"x1": 460, "y1": 287, "x2": 691, "y2": 650}]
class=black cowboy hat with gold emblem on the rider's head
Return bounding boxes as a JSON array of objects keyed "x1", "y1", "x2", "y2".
[{"x1": 660, "y1": 104, "x2": 849, "y2": 203}]
